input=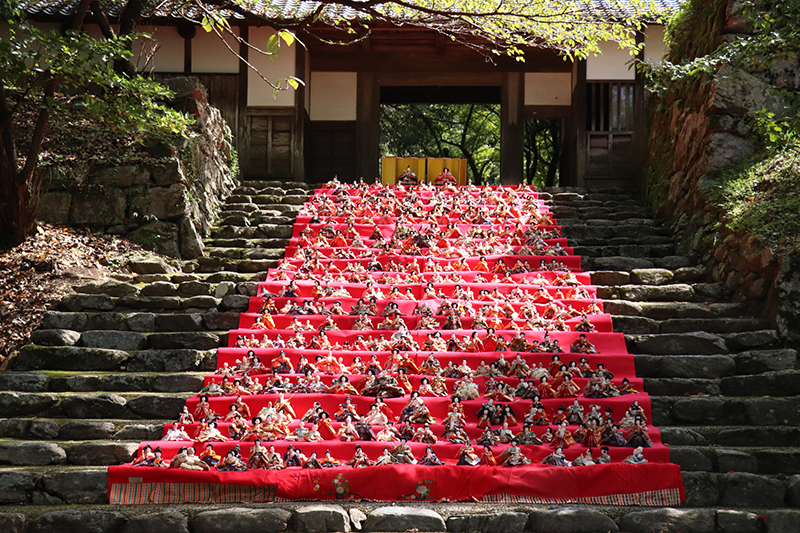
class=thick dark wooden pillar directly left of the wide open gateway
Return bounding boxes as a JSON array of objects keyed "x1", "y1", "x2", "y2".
[{"x1": 353, "y1": 72, "x2": 381, "y2": 183}]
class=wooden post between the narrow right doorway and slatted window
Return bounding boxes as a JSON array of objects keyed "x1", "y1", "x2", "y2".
[{"x1": 559, "y1": 60, "x2": 587, "y2": 187}]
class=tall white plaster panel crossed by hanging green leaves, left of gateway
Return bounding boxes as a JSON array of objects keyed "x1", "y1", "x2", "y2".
[{"x1": 247, "y1": 28, "x2": 298, "y2": 107}]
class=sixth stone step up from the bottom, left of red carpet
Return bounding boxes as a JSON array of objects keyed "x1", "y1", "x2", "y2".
[{"x1": 0, "y1": 370, "x2": 205, "y2": 392}]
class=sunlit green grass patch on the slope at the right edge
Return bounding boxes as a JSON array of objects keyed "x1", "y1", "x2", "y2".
[{"x1": 709, "y1": 144, "x2": 800, "y2": 252}]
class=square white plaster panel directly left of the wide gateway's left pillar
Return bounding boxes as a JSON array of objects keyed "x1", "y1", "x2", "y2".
[{"x1": 309, "y1": 72, "x2": 358, "y2": 120}]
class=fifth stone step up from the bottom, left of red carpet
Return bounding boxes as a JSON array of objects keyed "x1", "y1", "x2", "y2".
[{"x1": 0, "y1": 391, "x2": 192, "y2": 420}]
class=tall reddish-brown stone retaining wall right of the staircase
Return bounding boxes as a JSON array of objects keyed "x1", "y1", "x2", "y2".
[{"x1": 644, "y1": 0, "x2": 800, "y2": 341}]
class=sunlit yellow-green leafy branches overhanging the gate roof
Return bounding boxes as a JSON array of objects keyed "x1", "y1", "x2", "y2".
[{"x1": 192, "y1": 0, "x2": 678, "y2": 61}]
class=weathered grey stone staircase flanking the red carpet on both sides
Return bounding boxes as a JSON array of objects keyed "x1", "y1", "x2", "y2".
[{"x1": 0, "y1": 182, "x2": 800, "y2": 533}]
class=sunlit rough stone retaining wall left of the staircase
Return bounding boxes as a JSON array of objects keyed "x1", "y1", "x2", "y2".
[{"x1": 39, "y1": 78, "x2": 235, "y2": 259}]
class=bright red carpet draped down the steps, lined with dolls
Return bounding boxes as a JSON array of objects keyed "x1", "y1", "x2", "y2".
[{"x1": 109, "y1": 182, "x2": 683, "y2": 505}]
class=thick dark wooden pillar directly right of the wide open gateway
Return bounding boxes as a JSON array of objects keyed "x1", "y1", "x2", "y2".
[{"x1": 500, "y1": 72, "x2": 525, "y2": 184}]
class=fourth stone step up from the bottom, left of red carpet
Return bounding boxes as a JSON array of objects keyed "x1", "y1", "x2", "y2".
[{"x1": 0, "y1": 418, "x2": 166, "y2": 441}]
